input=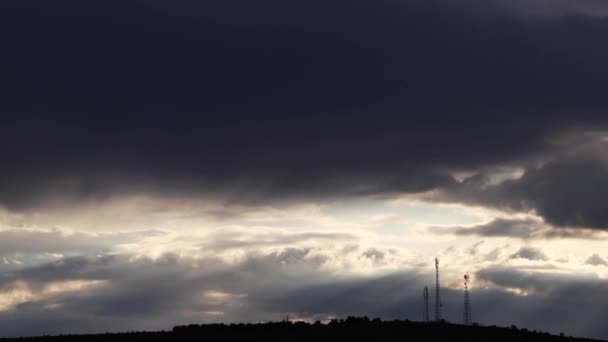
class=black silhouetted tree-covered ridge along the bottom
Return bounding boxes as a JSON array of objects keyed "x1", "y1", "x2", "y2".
[{"x1": 0, "y1": 317, "x2": 598, "y2": 342}]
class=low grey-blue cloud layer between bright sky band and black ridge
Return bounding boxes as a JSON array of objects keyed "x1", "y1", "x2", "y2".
[{"x1": 0, "y1": 249, "x2": 606, "y2": 337}]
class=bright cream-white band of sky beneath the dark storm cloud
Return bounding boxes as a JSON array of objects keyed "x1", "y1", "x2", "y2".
[{"x1": 0, "y1": 192, "x2": 608, "y2": 286}]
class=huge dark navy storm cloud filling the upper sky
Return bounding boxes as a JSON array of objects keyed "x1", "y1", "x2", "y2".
[{"x1": 0, "y1": 0, "x2": 608, "y2": 210}]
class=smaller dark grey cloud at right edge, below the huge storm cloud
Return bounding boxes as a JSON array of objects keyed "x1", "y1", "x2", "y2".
[{"x1": 431, "y1": 155, "x2": 608, "y2": 230}]
